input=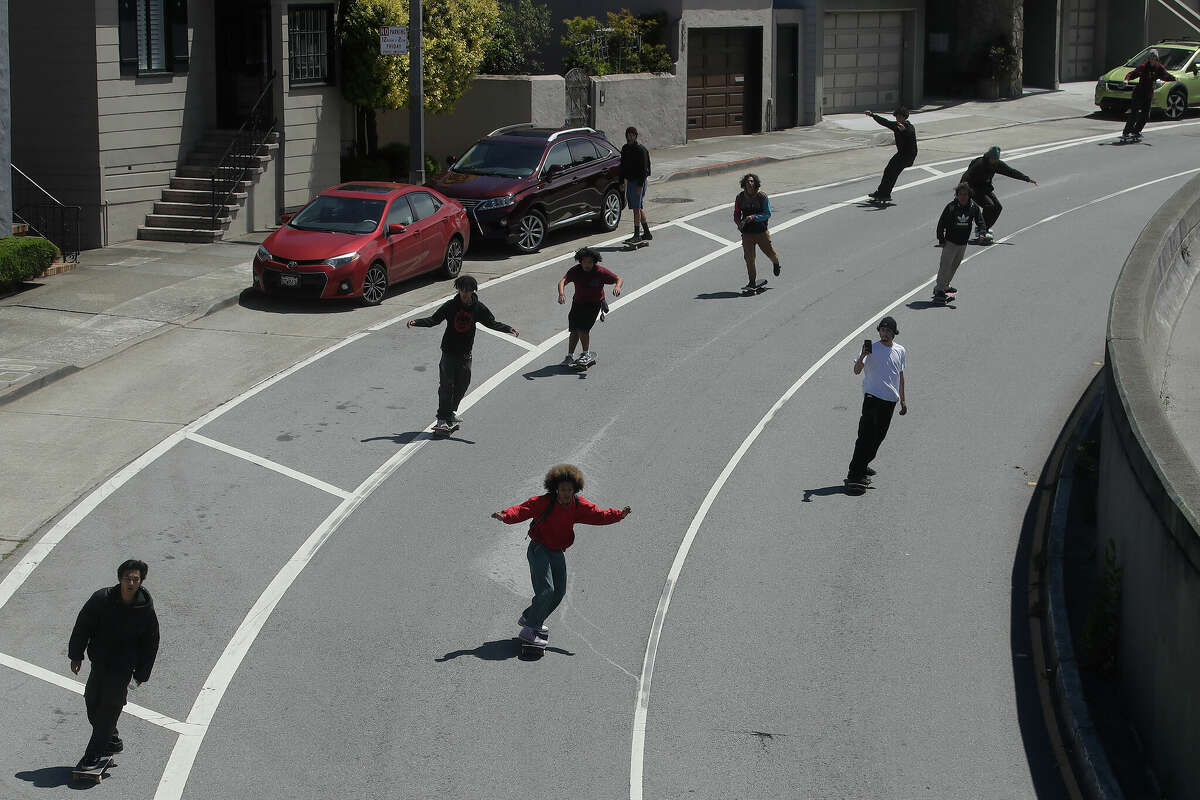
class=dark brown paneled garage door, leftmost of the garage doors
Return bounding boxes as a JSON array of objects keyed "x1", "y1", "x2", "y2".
[{"x1": 688, "y1": 28, "x2": 752, "y2": 139}]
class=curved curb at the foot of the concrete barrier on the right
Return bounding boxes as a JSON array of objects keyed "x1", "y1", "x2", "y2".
[{"x1": 1042, "y1": 373, "x2": 1124, "y2": 800}]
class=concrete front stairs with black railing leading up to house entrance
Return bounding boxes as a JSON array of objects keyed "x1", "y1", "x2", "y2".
[{"x1": 138, "y1": 130, "x2": 280, "y2": 243}]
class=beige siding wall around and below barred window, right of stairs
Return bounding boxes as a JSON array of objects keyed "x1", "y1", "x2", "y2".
[{"x1": 272, "y1": 0, "x2": 343, "y2": 210}]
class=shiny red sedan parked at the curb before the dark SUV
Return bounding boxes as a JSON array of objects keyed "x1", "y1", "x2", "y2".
[{"x1": 254, "y1": 181, "x2": 470, "y2": 306}]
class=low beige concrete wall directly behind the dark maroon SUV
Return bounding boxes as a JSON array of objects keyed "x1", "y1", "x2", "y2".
[{"x1": 377, "y1": 76, "x2": 566, "y2": 163}]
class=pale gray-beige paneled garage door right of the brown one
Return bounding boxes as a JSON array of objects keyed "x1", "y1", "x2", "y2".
[{"x1": 821, "y1": 11, "x2": 904, "y2": 114}]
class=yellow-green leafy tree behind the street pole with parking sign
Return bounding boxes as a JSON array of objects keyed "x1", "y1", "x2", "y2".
[{"x1": 337, "y1": 0, "x2": 499, "y2": 155}]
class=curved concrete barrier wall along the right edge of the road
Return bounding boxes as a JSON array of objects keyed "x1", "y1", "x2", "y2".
[{"x1": 1097, "y1": 178, "x2": 1200, "y2": 798}]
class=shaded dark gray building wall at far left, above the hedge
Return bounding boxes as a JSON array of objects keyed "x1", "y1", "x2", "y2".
[{"x1": 8, "y1": 0, "x2": 102, "y2": 248}]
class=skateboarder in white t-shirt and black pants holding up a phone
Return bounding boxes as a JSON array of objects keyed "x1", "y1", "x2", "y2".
[{"x1": 846, "y1": 317, "x2": 908, "y2": 483}]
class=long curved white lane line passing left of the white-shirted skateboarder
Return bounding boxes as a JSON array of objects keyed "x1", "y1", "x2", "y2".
[{"x1": 629, "y1": 167, "x2": 1200, "y2": 800}]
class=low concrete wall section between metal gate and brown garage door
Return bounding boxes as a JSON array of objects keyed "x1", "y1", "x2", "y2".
[{"x1": 592, "y1": 73, "x2": 688, "y2": 149}]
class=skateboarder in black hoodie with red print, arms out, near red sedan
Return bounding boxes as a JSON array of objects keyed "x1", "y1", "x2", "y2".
[{"x1": 408, "y1": 275, "x2": 521, "y2": 434}]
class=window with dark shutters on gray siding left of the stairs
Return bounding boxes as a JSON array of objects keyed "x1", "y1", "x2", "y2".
[{"x1": 118, "y1": 0, "x2": 188, "y2": 76}]
